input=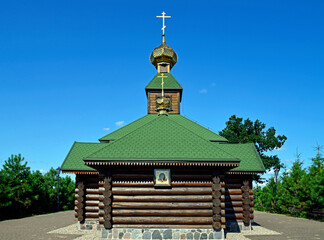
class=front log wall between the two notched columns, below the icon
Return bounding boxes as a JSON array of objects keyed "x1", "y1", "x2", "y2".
[{"x1": 112, "y1": 168, "x2": 213, "y2": 228}]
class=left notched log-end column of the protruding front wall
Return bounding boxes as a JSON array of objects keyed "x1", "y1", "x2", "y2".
[{"x1": 103, "y1": 172, "x2": 112, "y2": 229}]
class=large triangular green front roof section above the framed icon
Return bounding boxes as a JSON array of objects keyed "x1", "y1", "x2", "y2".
[{"x1": 85, "y1": 115, "x2": 239, "y2": 161}]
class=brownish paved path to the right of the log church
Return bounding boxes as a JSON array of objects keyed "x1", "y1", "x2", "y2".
[{"x1": 245, "y1": 211, "x2": 324, "y2": 240}]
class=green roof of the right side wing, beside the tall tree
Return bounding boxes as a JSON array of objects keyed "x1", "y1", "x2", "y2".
[{"x1": 216, "y1": 143, "x2": 265, "y2": 172}]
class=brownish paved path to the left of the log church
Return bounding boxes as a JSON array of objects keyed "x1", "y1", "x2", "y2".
[{"x1": 0, "y1": 211, "x2": 80, "y2": 240}]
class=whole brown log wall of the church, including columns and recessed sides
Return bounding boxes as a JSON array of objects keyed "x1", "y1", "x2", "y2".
[{"x1": 75, "y1": 167, "x2": 253, "y2": 230}]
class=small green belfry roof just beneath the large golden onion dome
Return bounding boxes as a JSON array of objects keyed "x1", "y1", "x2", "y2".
[{"x1": 145, "y1": 73, "x2": 182, "y2": 89}]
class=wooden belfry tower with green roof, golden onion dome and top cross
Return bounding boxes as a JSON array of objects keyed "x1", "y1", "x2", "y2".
[{"x1": 145, "y1": 12, "x2": 182, "y2": 114}]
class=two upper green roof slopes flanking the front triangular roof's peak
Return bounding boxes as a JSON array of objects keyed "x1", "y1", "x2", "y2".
[{"x1": 99, "y1": 114, "x2": 227, "y2": 142}]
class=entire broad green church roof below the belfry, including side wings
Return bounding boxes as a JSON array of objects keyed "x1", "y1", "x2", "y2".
[{"x1": 62, "y1": 114, "x2": 265, "y2": 172}]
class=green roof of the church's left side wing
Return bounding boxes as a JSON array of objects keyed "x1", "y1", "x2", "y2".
[{"x1": 61, "y1": 142, "x2": 105, "y2": 171}]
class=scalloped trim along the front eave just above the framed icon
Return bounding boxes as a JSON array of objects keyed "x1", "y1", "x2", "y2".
[{"x1": 84, "y1": 160, "x2": 240, "y2": 167}]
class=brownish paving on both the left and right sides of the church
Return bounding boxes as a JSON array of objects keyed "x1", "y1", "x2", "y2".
[{"x1": 0, "y1": 211, "x2": 324, "y2": 240}]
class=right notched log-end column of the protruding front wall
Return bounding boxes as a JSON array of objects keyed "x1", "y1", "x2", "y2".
[{"x1": 212, "y1": 170, "x2": 222, "y2": 231}]
